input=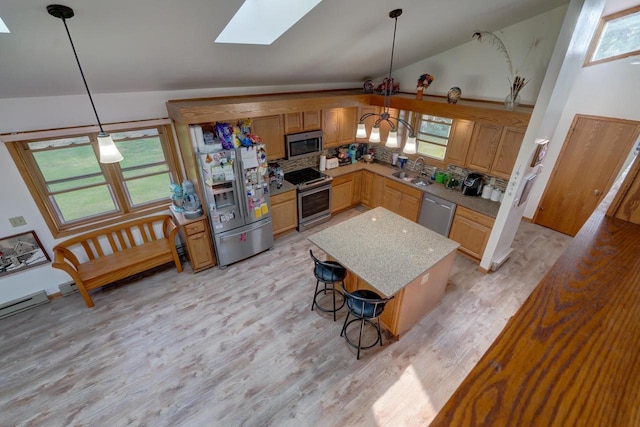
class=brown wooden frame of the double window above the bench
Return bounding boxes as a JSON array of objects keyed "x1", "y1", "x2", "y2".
[{"x1": 2, "y1": 119, "x2": 184, "y2": 238}]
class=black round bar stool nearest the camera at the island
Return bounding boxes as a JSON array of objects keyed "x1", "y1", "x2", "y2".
[{"x1": 340, "y1": 283, "x2": 393, "y2": 360}]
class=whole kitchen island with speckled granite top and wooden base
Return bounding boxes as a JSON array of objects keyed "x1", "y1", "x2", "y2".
[{"x1": 309, "y1": 207, "x2": 459, "y2": 339}]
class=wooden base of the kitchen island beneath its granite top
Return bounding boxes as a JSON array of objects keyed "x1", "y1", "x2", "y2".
[{"x1": 345, "y1": 251, "x2": 456, "y2": 340}]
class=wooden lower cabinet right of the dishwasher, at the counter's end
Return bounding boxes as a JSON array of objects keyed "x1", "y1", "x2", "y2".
[{"x1": 449, "y1": 206, "x2": 495, "y2": 261}]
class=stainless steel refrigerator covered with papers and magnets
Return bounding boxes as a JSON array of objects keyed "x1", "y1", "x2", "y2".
[{"x1": 197, "y1": 144, "x2": 273, "y2": 268}]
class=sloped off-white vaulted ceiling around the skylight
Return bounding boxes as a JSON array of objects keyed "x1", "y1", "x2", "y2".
[{"x1": 0, "y1": 0, "x2": 568, "y2": 98}]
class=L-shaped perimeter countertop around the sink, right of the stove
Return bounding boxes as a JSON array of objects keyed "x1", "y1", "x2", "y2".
[{"x1": 323, "y1": 162, "x2": 500, "y2": 218}]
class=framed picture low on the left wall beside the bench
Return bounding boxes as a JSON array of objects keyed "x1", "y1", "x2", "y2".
[{"x1": 0, "y1": 231, "x2": 51, "y2": 277}]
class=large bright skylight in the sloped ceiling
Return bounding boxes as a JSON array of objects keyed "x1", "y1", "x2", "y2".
[{"x1": 216, "y1": 0, "x2": 322, "y2": 45}]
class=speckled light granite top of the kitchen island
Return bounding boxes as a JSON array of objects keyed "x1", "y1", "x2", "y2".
[{"x1": 309, "y1": 207, "x2": 460, "y2": 297}]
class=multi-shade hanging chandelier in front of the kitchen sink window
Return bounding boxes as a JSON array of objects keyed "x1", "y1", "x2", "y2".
[{"x1": 356, "y1": 9, "x2": 416, "y2": 154}]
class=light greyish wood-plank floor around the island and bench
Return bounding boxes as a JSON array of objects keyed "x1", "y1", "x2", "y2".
[{"x1": 0, "y1": 209, "x2": 570, "y2": 426}]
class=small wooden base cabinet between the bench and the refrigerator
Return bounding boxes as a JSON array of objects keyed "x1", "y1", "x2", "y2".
[{"x1": 172, "y1": 210, "x2": 216, "y2": 273}]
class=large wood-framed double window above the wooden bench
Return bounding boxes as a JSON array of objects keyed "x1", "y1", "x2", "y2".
[{"x1": 8, "y1": 122, "x2": 181, "y2": 237}]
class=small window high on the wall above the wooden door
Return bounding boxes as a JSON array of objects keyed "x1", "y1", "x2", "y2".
[{"x1": 585, "y1": 6, "x2": 640, "y2": 65}]
